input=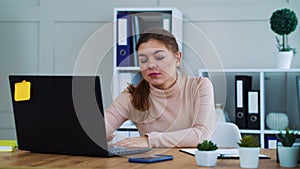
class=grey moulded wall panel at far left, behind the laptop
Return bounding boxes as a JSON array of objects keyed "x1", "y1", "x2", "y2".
[{"x1": 0, "y1": 22, "x2": 39, "y2": 112}]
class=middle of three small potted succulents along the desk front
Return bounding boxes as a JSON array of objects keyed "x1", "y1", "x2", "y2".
[{"x1": 238, "y1": 135, "x2": 260, "y2": 168}]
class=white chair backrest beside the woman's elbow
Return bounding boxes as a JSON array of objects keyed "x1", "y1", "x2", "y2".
[{"x1": 211, "y1": 122, "x2": 242, "y2": 148}]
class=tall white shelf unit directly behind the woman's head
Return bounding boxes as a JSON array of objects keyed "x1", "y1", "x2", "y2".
[{"x1": 113, "y1": 7, "x2": 183, "y2": 98}]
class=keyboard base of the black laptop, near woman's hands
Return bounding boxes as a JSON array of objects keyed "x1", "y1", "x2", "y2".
[{"x1": 109, "y1": 146, "x2": 151, "y2": 155}]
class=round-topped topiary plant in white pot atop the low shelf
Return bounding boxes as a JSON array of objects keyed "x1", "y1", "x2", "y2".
[{"x1": 270, "y1": 8, "x2": 298, "y2": 69}]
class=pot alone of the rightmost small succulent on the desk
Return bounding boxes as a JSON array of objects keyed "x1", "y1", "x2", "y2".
[{"x1": 278, "y1": 146, "x2": 299, "y2": 167}]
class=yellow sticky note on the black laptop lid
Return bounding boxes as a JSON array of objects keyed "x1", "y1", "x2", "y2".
[{"x1": 15, "y1": 80, "x2": 31, "y2": 101}]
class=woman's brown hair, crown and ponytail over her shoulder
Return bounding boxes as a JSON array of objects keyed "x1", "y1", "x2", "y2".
[{"x1": 127, "y1": 28, "x2": 179, "y2": 111}]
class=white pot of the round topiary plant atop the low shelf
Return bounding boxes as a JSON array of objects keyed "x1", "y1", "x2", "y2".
[{"x1": 277, "y1": 51, "x2": 294, "y2": 69}]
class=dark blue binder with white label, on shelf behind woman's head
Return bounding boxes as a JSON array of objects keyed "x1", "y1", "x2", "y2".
[{"x1": 117, "y1": 13, "x2": 132, "y2": 66}]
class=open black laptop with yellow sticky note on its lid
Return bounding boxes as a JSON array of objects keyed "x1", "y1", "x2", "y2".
[{"x1": 9, "y1": 75, "x2": 151, "y2": 157}]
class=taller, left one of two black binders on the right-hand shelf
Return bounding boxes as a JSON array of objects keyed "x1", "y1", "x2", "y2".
[{"x1": 235, "y1": 76, "x2": 252, "y2": 129}]
